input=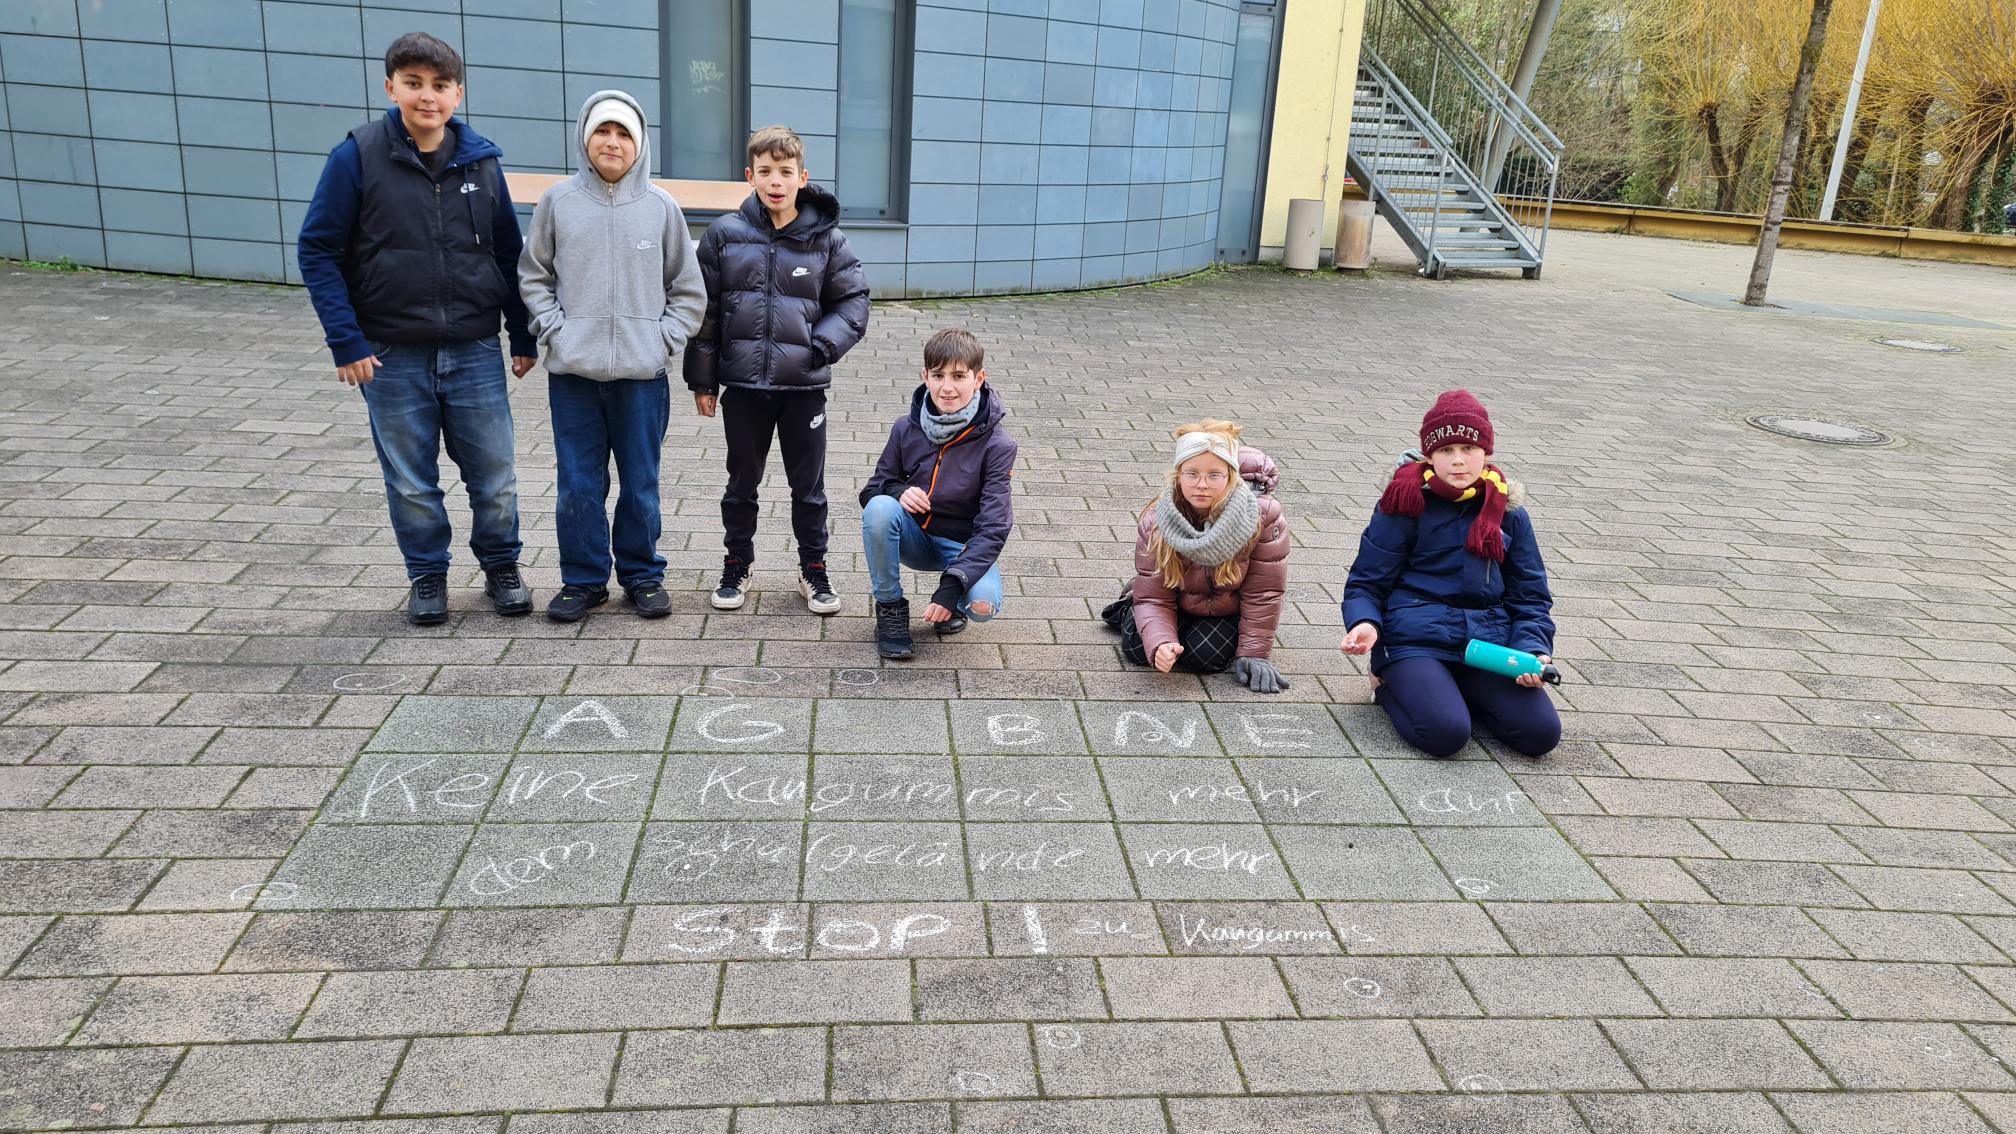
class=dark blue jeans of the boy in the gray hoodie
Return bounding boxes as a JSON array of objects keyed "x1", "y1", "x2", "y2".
[{"x1": 546, "y1": 373, "x2": 671, "y2": 587}]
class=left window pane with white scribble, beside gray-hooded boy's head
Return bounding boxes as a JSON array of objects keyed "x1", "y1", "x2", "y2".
[{"x1": 659, "y1": 0, "x2": 748, "y2": 182}]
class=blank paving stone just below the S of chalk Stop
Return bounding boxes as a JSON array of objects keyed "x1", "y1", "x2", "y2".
[{"x1": 512, "y1": 965, "x2": 718, "y2": 1031}]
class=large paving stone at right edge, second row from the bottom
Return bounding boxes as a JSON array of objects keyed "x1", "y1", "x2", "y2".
[{"x1": 1786, "y1": 1019, "x2": 2016, "y2": 1090}]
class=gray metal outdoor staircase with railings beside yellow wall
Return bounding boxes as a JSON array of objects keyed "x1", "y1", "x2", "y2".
[{"x1": 1347, "y1": 0, "x2": 1562, "y2": 280}]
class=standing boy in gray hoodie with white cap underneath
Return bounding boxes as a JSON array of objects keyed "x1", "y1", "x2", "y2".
[{"x1": 518, "y1": 91, "x2": 708, "y2": 621}]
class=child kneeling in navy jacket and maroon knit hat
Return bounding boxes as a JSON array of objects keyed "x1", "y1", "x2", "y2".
[{"x1": 1343, "y1": 389, "x2": 1560, "y2": 757}]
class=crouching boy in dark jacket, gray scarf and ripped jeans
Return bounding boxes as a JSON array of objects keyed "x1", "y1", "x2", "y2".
[{"x1": 861, "y1": 329, "x2": 1016, "y2": 660}]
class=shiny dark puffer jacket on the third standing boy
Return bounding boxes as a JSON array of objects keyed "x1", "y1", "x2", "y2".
[{"x1": 685, "y1": 186, "x2": 869, "y2": 393}]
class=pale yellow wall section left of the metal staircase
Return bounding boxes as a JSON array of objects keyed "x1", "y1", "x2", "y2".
[{"x1": 1260, "y1": 0, "x2": 1365, "y2": 260}]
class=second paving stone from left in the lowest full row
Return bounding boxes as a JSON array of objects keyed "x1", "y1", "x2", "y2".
[{"x1": 147, "y1": 1039, "x2": 403, "y2": 1122}]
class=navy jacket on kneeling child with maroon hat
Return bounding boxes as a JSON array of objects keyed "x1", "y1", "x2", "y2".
[{"x1": 1345, "y1": 492, "x2": 1554, "y2": 674}]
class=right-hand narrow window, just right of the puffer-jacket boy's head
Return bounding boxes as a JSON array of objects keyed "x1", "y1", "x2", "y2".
[{"x1": 833, "y1": 0, "x2": 913, "y2": 220}]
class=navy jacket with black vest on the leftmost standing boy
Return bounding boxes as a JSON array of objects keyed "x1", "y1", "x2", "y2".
[{"x1": 298, "y1": 107, "x2": 538, "y2": 365}]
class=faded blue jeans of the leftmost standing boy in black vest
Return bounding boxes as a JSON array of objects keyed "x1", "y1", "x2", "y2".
[{"x1": 359, "y1": 335, "x2": 524, "y2": 579}]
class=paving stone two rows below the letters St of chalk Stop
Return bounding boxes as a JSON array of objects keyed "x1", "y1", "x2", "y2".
[{"x1": 615, "y1": 1027, "x2": 827, "y2": 1106}]
